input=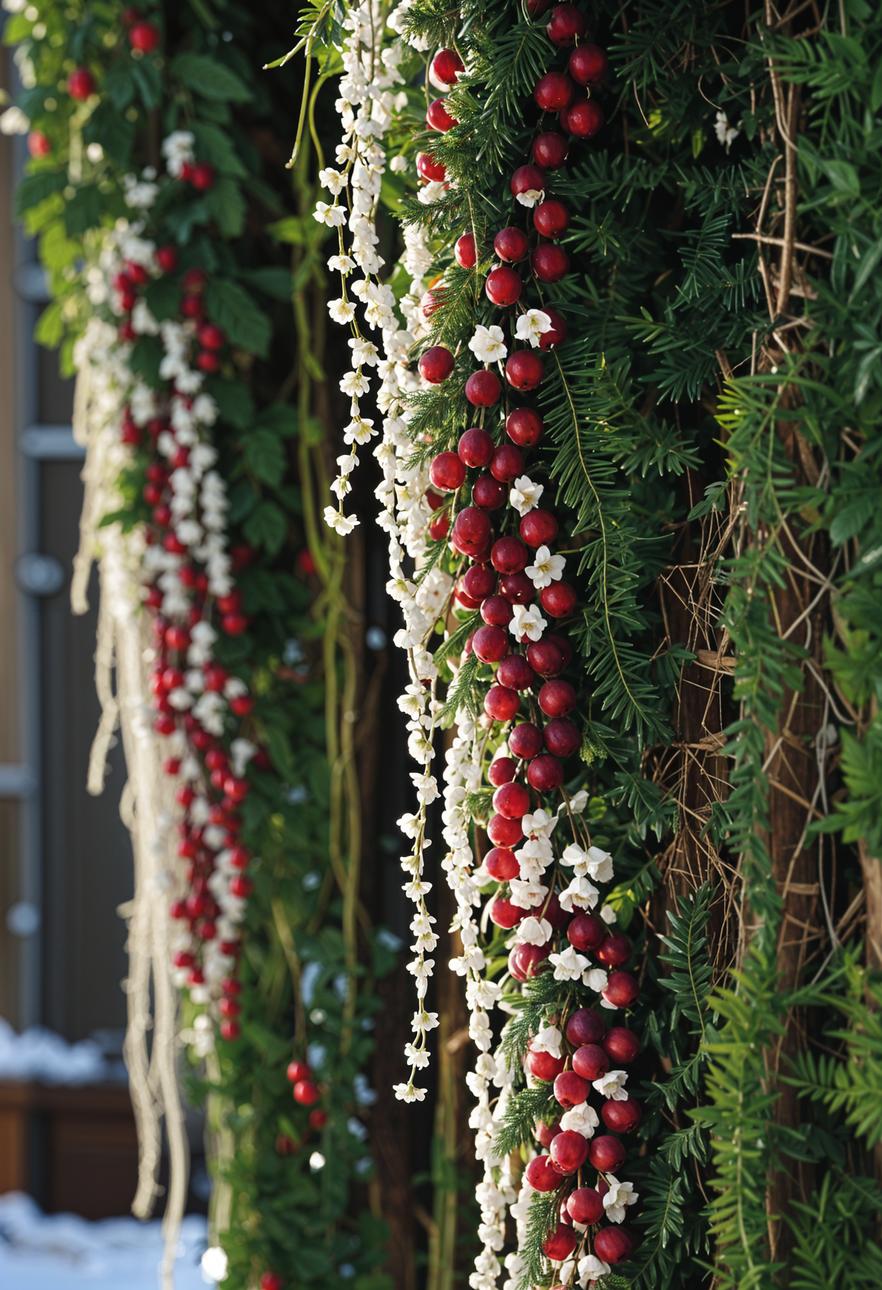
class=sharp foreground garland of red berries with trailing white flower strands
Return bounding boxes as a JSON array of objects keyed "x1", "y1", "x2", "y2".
[{"x1": 320, "y1": 5, "x2": 640, "y2": 1290}]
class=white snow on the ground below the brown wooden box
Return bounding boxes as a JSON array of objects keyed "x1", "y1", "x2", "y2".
[{"x1": 0, "y1": 1192, "x2": 213, "y2": 1290}]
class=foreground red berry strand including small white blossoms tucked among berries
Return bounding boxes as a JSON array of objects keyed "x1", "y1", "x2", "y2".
[{"x1": 418, "y1": 0, "x2": 641, "y2": 1285}]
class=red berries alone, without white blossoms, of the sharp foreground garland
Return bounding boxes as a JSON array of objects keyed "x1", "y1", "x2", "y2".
[{"x1": 418, "y1": 0, "x2": 641, "y2": 1263}]
